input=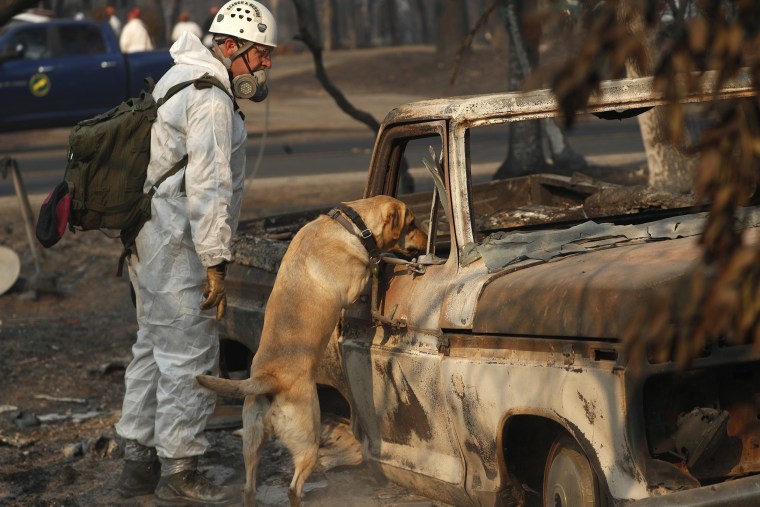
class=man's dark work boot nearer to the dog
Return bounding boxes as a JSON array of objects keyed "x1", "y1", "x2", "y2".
[{"x1": 156, "y1": 458, "x2": 233, "y2": 505}]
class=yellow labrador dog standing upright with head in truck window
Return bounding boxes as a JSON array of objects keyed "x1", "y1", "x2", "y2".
[{"x1": 198, "y1": 196, "x2": 427, "y2": 506}]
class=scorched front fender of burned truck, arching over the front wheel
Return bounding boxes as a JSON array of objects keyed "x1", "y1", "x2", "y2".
[{"x1": 441, "y1": 344, "x2": 647, "y2": 499}]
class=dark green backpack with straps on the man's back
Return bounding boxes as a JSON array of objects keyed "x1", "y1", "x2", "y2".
[{"x1": 64, "y1": 74, "x2": 234, "y2": 275}]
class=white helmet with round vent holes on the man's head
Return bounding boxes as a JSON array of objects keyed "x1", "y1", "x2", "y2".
[{"x1": 208, "y1": 0, "x2": 277, "y2": 47}]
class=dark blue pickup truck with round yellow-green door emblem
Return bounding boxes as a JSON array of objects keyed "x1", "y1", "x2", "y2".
[{"x1": 0, "y1": 18, "x2": 173, "y2": 132}]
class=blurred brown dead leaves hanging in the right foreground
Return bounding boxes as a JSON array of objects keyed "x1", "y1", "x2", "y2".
[{"x1": 552, "y1": 0, "x2": 760, "y2": 366}]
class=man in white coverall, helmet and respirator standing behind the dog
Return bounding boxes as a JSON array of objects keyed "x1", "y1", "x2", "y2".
[{"x1": 116, "y1": 0, "x2": 277, "y2": 505}]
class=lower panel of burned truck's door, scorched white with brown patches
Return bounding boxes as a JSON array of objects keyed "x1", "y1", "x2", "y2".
[{"x1": 343, "y1": 328, "x2": 464, "y2": 492}]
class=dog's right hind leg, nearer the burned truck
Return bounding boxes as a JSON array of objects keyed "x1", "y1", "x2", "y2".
[{"x1": 272, "y1": 384, "x2": 320, "y2": 507}]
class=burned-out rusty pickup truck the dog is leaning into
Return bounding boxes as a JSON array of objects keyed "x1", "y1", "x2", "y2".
[{"x1": 217, "y1": 72, "x2": 760, "y2": 507}]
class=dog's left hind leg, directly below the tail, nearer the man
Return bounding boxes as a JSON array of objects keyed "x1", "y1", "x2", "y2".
[{"x1": 243, "y1": 396, "x2": 272, "y2": 507}]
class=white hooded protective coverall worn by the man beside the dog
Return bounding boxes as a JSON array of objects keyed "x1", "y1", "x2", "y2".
[{"x1": 116, "y1": 33, "x2": 247, "y2": 459}]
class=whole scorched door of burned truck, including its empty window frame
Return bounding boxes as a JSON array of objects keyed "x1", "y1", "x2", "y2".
[{"x1": 344, "y1": 122, "x2": 466, "y2": 502}]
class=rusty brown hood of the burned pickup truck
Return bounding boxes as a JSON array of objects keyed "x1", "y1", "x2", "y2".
[{"x1": 472, "y1": 238, "x2": 700, "y2": 339}]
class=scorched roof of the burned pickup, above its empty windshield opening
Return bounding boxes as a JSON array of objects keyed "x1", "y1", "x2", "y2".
[{"x1": 383, "y1": 69, "x2": 757, "y2": 125}]
